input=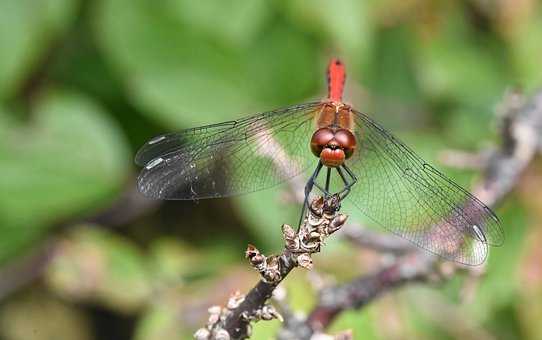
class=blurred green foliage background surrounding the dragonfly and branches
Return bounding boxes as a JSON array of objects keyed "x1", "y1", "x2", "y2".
[{"x1": 0, "y1": 0, "x2": 542, "y2": 340}]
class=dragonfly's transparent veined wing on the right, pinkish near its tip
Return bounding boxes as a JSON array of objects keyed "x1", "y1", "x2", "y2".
[{"x1": 346, "y1": 111, "x2": 504, "y2": 265}]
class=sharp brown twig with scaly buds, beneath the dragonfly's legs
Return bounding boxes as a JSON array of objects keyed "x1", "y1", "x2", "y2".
[{"x1": 195, "y1": 195, "x2": 346, "y2": 340}]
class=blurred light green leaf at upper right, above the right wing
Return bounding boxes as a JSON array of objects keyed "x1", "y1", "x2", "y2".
[{"x1": 415, "y1": 8, "x2": 508, "y2": 107}]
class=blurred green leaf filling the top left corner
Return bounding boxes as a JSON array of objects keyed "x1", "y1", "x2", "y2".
[{"x1": 0, "y1": 0, "x2": 78, "y2": 99}]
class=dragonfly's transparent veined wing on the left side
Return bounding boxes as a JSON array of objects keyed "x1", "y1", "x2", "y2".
[{"x1": 135, "y1": 102, "x2": 321, "y2": 200}]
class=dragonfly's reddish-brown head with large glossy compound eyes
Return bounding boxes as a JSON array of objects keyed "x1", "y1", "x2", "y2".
[{"x1": 311, "y1": 127, "x2": 356, "y2": 168}]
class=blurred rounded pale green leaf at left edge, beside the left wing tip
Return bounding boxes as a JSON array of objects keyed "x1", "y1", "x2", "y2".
[{"x1": 0, "y1": 91, "x2": 129, "y2": 262}]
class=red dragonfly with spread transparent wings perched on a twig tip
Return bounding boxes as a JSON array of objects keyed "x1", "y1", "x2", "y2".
[{"x1": 135, "y1": 59, "x2": 504, "y2": 265}]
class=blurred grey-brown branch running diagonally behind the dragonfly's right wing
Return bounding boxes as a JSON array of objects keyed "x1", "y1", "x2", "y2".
[{"x1": 279, "y1": 91, "x2": 542, "y2": 340}]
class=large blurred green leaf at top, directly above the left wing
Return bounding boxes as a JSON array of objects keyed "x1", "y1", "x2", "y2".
[{"x1": 94, "y1": 0, "x2": 324, "y2": 127}]
